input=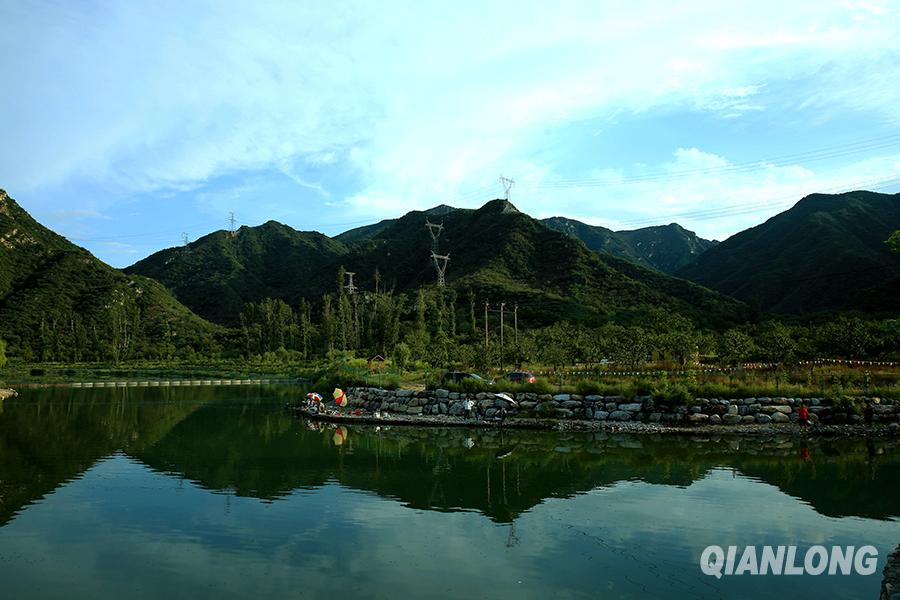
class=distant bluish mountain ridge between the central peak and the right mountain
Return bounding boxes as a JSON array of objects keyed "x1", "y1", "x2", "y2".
[{"x1": 541, "y1": 217, "x2": 718, "y2": 274}]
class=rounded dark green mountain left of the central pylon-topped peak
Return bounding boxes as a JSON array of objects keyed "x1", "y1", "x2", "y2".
[{"x1": 125, "y1": 221, "x2": 347, "y2": 325}]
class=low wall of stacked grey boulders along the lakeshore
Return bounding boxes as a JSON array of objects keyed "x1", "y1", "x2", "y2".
[{"x1": 347, "y1": 388, "x2": 900, "y2": 425}]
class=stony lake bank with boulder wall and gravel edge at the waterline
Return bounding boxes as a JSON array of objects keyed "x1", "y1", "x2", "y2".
[{"x1": 295, "y1": 388, "x2": 900, "y2": 436}]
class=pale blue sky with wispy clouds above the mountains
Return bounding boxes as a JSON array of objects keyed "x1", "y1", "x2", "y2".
[{"x1": 0, "y1": 0, "x2": 900, "y2": 266}]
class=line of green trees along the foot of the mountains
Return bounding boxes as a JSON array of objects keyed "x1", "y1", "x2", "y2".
[{"x1": 0, "y1": 272, "x2": 900, "y2": 371}]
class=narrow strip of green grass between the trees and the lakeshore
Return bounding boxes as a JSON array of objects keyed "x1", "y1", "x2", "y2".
[{"x1": 0, "y1": 357, "x2": 900, "y2": 403}]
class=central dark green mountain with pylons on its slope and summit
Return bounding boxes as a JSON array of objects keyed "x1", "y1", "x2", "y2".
[{"x1": 326, "y1": 200, "x2": 742, "y2": 322}]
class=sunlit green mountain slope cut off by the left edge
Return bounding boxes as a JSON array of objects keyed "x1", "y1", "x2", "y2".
[{"x1": 0, "y1": 190, "x2": 218, "y2": 360}]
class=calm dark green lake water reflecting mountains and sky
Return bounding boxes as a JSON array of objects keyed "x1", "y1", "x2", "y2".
[{"x1": 0, "y1": 386, "x2": 900, "y2": 599}]
